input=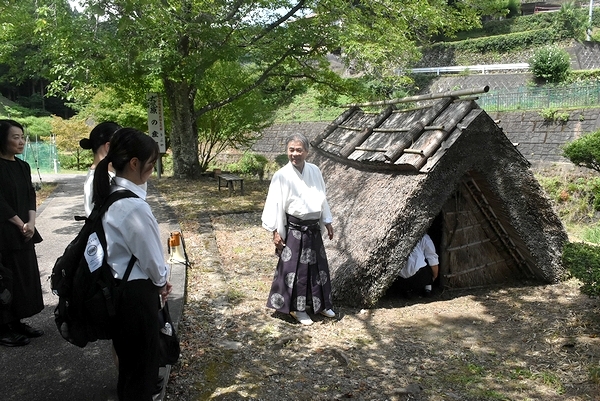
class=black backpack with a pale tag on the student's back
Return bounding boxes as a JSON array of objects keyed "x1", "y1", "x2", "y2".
[{"x1": 50, "y1": 190, "x2": 137, "y2": 347}]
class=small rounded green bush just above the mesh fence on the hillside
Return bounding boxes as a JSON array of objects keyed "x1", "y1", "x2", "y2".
[{"x1": 529, "y1": 46, "x2": 571, "y2": 83}]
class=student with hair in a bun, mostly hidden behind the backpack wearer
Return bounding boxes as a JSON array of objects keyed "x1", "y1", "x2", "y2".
[{"x1": 79, "y1": 121, "x2": 121, "y2": 217}]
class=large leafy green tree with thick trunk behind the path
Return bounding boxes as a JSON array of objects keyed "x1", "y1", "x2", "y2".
[{"x1": 0, "y1": 0, "x2": 497, "y2": 177}]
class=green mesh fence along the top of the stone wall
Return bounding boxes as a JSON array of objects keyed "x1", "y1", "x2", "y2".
[{"x1": 477, "y1": 82, "x2": 600, "y2": 111}]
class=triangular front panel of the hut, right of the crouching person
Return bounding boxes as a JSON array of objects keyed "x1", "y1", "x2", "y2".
[{"x1": 438, "y1": 173, "x2": 528, "y2": 288}]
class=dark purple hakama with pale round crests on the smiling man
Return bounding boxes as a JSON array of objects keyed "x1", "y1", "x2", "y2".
[{"x1": 267, "y1": 215, "x2": 333, "y2": 314}]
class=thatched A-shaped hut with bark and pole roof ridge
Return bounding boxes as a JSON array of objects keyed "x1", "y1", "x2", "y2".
[{"x1": 311, "y1": 88, "x2": 567, "y2": 306}]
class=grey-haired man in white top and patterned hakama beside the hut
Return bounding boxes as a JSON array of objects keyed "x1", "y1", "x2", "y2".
[{"x1": 262, "y1": 134, "x2": 335, "y2": 325}]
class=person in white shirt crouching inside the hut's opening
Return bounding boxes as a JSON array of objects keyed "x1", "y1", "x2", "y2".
[{"x1": 396, "y1": 234, "x2": 439, "y2": 298}]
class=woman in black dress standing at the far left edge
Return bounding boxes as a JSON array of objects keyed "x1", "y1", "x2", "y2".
[{"x1": 0, "y1": 120, "x2": 44, "y2": 347}]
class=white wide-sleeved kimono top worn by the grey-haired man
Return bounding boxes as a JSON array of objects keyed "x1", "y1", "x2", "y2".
[{"x1": 262, "y1": 162, "x2": 333, "y2": 241}]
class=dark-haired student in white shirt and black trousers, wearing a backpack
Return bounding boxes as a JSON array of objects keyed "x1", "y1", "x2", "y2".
[{"x1": 93, "y1": 128, "x2": 171, "y2": 401}]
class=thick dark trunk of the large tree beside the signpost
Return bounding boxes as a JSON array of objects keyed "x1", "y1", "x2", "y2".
[{"x1": 163, "y1": 79, "x2": 201, "y2": 178}]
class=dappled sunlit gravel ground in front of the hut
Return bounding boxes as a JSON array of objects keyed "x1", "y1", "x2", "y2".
[{"x1": 161, "y1": 206, "x2": 600, "y2": 401}]
